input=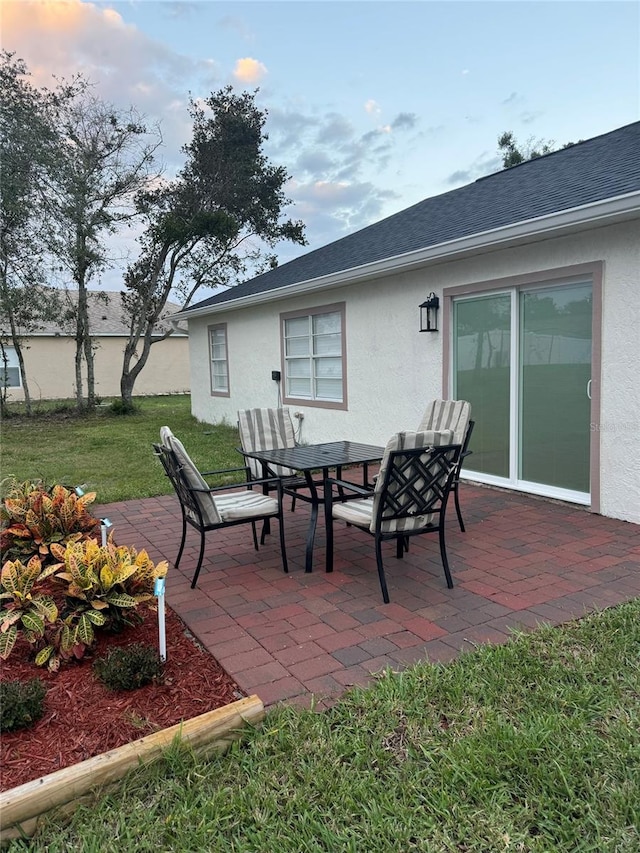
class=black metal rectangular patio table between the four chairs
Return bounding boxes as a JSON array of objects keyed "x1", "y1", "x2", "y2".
[{"x1": 242, "y1": 441, "x2": 384, "y2": 572}]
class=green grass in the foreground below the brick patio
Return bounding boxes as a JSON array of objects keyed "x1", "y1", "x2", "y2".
[{"x1": 12, "y1": 601, "x2": 640, "y2": 853}]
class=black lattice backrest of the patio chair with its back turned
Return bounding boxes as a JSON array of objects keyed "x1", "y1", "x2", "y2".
[{"x1": 376, "y1": 429, "x2": 460, "y2": 533}]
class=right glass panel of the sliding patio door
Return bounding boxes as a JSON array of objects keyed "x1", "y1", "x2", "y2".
[{"x1": 518, "y1": 284, "x2": 592, "y2": 492}]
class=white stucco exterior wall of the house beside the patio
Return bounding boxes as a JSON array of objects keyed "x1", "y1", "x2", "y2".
[{"x1": 189, "y1": 222, "x2": 640, "y2": 522}]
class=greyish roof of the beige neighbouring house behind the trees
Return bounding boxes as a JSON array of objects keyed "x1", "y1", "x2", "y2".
[{"x1": 23, "y1": 290, "x2": 187, "y2": 337}]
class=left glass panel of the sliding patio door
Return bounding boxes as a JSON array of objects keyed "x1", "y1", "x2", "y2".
[{"x1": 454, "y1": 293, "x2": 511, "y2": 477}]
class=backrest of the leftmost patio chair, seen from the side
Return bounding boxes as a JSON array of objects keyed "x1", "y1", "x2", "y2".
[{"x1": 154, "y1": 426, "x2": 222, "y2": 525}]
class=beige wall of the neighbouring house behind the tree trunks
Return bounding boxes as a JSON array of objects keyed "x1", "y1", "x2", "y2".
[{"x1": 7, "y1": 336, "x2": 190, "y2": 401}]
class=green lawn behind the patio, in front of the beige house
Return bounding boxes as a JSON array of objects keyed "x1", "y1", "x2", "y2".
[{"x1": 0, "y1": 395, "x2": 242, "y2": 504}]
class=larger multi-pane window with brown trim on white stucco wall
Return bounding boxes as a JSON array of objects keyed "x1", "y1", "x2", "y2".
[{"x1": 282, "y1": 303, "x2": 347, "y2": 408}]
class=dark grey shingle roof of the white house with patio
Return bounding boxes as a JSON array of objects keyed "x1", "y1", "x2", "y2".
[{"x1": 180, "y1": 122, "x2": 640, "y2": 318}]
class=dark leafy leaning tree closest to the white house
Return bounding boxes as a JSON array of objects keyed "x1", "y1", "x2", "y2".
[{"x1": 120, "y1": 86, "x2": 306, "y2": 411}]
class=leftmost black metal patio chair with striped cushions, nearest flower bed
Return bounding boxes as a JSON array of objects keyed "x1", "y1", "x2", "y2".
[{"x1": 153, "y1": 427, "x2": 289, "y2": 589}]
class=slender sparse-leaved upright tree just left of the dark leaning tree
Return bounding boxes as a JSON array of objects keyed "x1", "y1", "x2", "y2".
[{"x1": 48, "y1": 87, "x2": 161, "y2": 409}]
